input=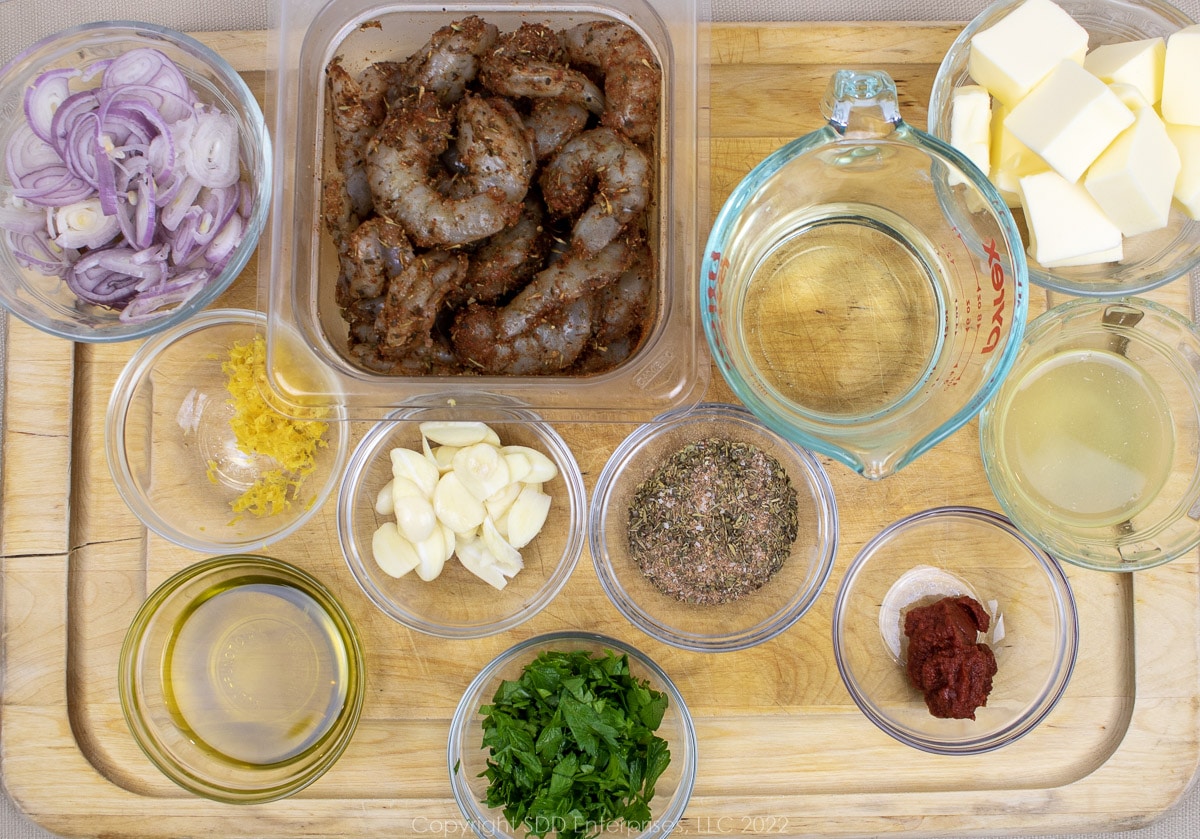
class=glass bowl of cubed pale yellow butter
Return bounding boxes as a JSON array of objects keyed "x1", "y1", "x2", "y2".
[{"x1": 929, "y1": 0, "x2": 1200, "y2": 298}]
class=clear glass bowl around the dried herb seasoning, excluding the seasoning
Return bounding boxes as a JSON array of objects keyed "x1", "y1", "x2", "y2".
[{"x1": 588, "y1": 403, "x2": 838, "y2": 652}]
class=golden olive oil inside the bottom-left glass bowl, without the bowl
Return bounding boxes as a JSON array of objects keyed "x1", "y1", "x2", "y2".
[{"x1": 163, "y1": 582, "x2": 349, "y2": 765}]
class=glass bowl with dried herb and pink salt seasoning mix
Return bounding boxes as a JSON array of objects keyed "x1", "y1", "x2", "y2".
[{"x1": 588, "y1": 403, "x2": 838, "y2": 652}]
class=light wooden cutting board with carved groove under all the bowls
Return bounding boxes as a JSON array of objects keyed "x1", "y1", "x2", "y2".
[{"x1": 0, "y1": 23, "x2": 1200, "y2": 839}]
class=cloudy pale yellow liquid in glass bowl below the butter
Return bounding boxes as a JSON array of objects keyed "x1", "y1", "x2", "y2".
[{"x1": 1003, "y1": 349, "x2": 1175, "y2": 527}]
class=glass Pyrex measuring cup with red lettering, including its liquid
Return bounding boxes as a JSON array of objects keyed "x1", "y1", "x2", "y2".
[{"x1": 701, "y1": 70, "x2": 1028, "y2": 479}]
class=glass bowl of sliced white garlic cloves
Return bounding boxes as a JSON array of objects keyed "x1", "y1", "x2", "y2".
[{"x1": 337, "y1": 392, "x2": 587, "y2": 639}]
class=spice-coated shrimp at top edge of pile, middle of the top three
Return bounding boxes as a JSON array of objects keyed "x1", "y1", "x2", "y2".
[{"x1": 479, "y1": 24, "x2": 605, "y2": 114}]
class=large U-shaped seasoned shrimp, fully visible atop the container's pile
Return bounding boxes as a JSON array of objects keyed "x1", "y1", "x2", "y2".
[{"x1": 367, "y1": 97, "x2": 533, "y2": 247}]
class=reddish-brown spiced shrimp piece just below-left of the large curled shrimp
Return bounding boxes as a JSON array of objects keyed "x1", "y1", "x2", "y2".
[{"x1": 376, "y1": 250, "x2": 467, "y2": 356}]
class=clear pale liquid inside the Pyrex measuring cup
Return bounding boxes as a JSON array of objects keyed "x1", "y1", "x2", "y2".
[{"x1": 740, "y1": 204, "x2": 947, "y2": 420}]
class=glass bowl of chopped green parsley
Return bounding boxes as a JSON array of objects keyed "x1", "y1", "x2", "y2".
[{"x1": 446, "y1": 631, "x2": 696, "y2": 839}]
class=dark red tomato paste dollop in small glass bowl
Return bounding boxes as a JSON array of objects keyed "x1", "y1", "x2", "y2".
[{"x1": 904, "y1": 595, "x2": 996, "y2": 719}]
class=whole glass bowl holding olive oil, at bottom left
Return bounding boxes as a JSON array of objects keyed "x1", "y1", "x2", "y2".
[{"x1": 118, "y1": 555, "x2": 365, "y2": 804}]
